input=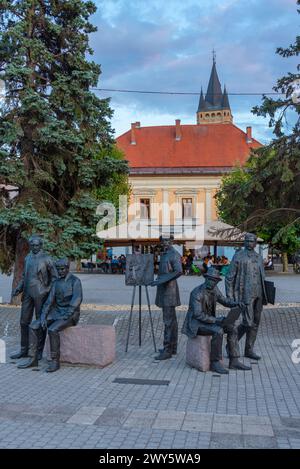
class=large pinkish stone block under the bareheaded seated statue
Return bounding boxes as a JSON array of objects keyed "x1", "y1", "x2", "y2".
[{"x1": 46, "y1": 324, "x2": 116, "y2": 368}]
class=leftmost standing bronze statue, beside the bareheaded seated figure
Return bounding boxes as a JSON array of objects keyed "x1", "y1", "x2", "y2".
[{"x1": 10, "y1": 236, "x2": 57, "y2": 359}]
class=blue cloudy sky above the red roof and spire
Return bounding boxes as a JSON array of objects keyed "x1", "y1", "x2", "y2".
[{"x1": 91, "y1": 0, "x2": 299, "y2": 142}]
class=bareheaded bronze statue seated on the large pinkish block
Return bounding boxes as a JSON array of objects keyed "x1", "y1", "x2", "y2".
[{"x1": 18, "y1": 259, "x2": 82, "y2": 372}]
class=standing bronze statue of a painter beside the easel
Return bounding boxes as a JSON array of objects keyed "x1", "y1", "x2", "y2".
[{"x1": 151, "y1": 236, "x2": 182, "y2": 360}]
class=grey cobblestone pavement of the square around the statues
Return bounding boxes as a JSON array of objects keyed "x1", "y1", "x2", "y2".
[{"x1": 0, "y1": 305, "x2": 300, "y2": 449}]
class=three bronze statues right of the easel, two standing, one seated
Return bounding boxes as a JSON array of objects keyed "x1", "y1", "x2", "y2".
[{"x1": 152, "y1": 233, "x2": 268, "y2": 374}]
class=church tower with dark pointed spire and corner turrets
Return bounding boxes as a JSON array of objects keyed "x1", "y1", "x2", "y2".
[{"x1": 197, "y1": 52, "x2": 232, "y2": 125}]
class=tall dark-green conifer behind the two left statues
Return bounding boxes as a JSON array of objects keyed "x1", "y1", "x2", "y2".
[{"x1": 0, "y1": 0, "x2": 128, "y2": 298}]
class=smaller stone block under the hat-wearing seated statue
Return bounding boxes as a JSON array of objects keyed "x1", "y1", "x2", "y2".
[{"x1": 186, "y1": 335, "x2": 211, "y2": 371}]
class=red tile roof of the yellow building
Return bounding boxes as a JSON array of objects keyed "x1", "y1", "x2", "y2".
[{"x1": 117, "y1": 123, "x2": 261, "y2": 173}]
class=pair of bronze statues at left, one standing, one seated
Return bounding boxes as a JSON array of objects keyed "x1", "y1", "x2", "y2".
[{"x1": 10, "y1": 236, "x2": 82, "y2": 372}]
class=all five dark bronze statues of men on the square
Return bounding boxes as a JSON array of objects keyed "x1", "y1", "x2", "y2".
[{"x1": 11, "y1": 233, "x2": 268, "y2": 374}]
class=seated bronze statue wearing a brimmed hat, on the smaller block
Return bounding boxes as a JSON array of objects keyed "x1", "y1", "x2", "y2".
[{"x1": 182, "y1": 267, "x2": 251, "y2": 374}]
